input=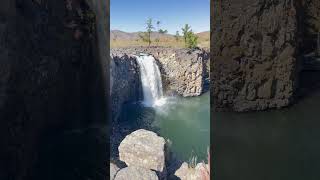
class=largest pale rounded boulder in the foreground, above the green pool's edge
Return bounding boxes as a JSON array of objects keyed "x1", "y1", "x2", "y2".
[{"x1": 118, "y1": 129, "x2": 165, "y2": 172}]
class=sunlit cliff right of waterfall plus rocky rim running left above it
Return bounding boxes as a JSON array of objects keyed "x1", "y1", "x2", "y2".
[{"x1": 111, "y1": 47, "x2": 210, "y2": 97}]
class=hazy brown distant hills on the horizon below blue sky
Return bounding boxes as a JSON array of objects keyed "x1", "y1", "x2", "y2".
[{"x1": 110, "y1": 30, "x2": 210, "y2": 41}]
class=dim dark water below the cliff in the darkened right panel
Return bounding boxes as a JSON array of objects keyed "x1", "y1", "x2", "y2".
[{"x1": 212, "y1": 90, "x2": 320, "y2": 180}]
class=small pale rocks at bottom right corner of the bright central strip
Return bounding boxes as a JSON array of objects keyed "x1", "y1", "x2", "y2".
[{"x1": 175, "y1": 162, "x2": 210, "y2": 180}]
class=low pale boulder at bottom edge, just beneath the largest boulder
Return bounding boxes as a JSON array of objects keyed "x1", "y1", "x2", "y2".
[{"x1": 115, "y1": 166, "x2": 159, "y2": 180}]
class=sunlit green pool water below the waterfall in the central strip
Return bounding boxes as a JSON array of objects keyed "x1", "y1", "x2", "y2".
[{"x1": 121, "y1": 93, "x2": 210, "y2": 161}]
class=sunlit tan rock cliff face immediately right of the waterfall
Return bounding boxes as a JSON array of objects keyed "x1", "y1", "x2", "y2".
[{"x1": 155, "y1": 49, "x2": 210, "y2": 97}]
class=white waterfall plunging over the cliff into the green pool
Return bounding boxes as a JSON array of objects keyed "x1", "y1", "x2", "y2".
[{"x1": 136, "y1": 54, "x2": 164, "y2": 107}]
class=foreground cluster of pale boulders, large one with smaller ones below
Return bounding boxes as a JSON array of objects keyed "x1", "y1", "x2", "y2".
[{"x1": 110, "y1": 129, "x2": 167, "y2": 180}]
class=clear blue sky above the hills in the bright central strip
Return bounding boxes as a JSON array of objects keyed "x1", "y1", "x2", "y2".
[{"x1": 110, "y1": 0, "x2": 210, "y2": 34}]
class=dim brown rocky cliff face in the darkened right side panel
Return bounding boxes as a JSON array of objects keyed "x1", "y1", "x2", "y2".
[{"x1": 211, "y1": 0, "x2": 301, "y2": 111}]
